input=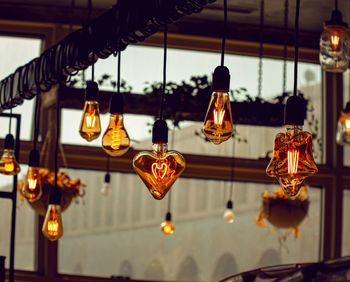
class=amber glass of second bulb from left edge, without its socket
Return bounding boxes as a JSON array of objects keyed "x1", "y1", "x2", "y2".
[{"x1": 22, "y1": 167, "x2": 42, "y2": 202}]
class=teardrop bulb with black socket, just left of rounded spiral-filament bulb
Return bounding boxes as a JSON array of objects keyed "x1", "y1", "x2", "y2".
[{"x1": 79, "y1": 81, "x2": 101, "y2": 142}]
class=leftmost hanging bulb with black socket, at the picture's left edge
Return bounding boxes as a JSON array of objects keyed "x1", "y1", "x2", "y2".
[{"x1": 0, "y1": 134, "x2": 21, "y2": 175}]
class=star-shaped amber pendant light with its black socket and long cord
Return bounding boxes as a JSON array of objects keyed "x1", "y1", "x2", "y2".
[{"x1": 266, "y1": 0, "x2": 317, "y2": 197}]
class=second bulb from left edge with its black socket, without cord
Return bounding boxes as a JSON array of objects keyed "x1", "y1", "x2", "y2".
[{"x1": 22, "y1": 149, "x2": 42, "y2": 202}]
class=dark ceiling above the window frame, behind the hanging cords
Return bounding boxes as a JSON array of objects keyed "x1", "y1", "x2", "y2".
[{"x1": 0, "y1": 0, "x2": 350, "y2": 48}]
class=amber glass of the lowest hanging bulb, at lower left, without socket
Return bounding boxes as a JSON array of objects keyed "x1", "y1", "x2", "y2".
[{"x1": 42, "y1": 204, "x2": 63, "y2": 241}]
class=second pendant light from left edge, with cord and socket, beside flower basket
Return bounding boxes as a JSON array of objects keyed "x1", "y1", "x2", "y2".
[{"x1": 22, "y1": 96, "x2": 42, "y2": 202}]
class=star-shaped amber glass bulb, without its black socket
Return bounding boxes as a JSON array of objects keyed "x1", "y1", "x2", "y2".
[{"x1": 266, "y1": 126, "x2": 317, "y2": 197}]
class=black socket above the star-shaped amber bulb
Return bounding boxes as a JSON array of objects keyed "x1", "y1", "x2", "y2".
[{"x1": 284, "y1": 95, "x2": 306, "y2": 126}]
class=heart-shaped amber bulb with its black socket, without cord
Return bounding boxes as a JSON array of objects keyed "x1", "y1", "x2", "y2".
[{"x1": 133, "y1": 119, "x2": 186, "y2": 200}]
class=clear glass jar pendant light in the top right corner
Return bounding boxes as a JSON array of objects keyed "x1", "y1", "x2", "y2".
[{"x1": 320, "y1": 0, "x2": 350, "y2": 72}]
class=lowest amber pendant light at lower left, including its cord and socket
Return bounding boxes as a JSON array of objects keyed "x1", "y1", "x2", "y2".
[{"x1": 42, "y1": 93, "x2": 63, "y2": 241}]
